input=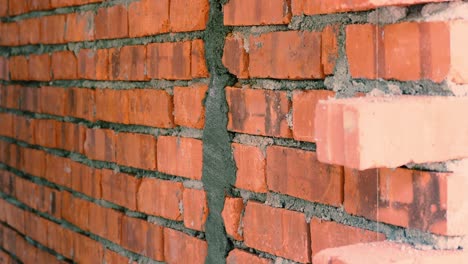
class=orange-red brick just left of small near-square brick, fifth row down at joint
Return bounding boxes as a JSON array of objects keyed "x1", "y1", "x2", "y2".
[{"x1": 137, "y1": 178, "x2": 184, "y2": 221}]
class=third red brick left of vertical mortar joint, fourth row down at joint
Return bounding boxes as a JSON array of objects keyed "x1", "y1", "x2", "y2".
[{"x1": 84, "y1": 128, "x2": 115, "y2": 162}]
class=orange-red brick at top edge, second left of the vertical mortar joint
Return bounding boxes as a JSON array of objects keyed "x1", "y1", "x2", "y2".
[{"x1": 128, "y1": 0, "x2": 169, "y2": 38}]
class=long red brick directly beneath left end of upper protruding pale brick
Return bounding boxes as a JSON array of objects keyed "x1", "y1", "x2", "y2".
[{"x1": 267, "y1": 146, "x2": 344, "y2": 206}]
